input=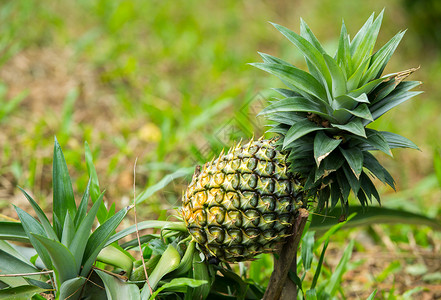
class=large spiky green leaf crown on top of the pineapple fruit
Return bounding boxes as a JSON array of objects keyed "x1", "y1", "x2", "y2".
[{"x1": 251, "y1": 12, "x2": 421, "y2": 209}]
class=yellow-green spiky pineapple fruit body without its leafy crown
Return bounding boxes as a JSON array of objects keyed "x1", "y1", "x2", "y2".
[{"x1": 182, "y1": 140, "x2": 304, "y2": 262}]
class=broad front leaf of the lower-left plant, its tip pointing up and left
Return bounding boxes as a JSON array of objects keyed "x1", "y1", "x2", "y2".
[{"x1": 32, "y1": 234, "x2": 78, "y2": 288}]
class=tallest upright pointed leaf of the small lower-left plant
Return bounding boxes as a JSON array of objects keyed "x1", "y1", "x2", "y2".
[{"x1": 52, "y1": 138, "x2": 77, "y2": 238}]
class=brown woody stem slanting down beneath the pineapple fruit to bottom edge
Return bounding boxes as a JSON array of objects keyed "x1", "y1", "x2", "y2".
[{"x1": 263, "y1": 208, "x2": 309, "y2": 300}]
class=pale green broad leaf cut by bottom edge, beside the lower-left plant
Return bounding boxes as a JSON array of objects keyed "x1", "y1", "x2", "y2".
[{"x1": 95, "y1": 270, "x2": 141, "y2": 300}]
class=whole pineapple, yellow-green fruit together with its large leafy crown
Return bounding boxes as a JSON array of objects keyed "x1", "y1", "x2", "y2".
[{"x1": 182, "y1": 13, "x2": 420, "y2": 262}]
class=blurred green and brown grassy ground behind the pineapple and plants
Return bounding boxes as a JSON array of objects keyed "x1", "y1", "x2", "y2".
[{"x1": 0, "y1": 0, "x2": 441, "y2": 292}]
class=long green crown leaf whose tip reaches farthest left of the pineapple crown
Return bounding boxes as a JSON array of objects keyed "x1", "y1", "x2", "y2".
[{"x1": 251, "y1": 63, "x2": 327, "y2": 100}]
